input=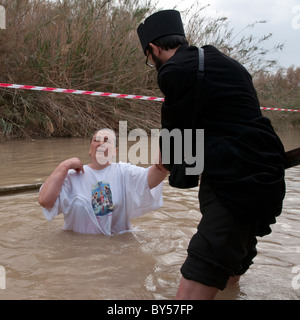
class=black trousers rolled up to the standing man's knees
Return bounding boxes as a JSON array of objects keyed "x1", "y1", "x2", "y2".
[{"x1": 181, "y1": 183, "x2": 268, "y2": 290}]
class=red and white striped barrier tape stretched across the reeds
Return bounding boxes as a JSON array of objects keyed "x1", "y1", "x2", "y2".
[{"x1": 0, "y1": 83, "x2": 300, "y2": 112}]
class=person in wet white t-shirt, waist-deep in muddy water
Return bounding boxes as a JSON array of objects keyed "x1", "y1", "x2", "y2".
[{"x1": 39, "y1": 129, "x2": 168, "y2": 235}]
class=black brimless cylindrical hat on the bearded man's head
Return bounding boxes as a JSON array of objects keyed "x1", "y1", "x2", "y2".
[{"x1": 137, "y1": 10, "x2": 185, "y2": 54}]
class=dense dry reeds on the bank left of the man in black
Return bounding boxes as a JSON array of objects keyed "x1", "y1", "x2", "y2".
[{"x1": 0, "y1": 0, "x2": 160, "y2": 138}]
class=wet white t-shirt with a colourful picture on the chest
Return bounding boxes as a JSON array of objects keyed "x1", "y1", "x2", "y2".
[{"x1": 43, "y1": 163, "x2": 163, "y2": 235}]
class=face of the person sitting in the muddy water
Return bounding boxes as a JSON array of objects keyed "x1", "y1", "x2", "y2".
[{"x1": 90, "y1": 130, "x2": 116, "y2": 165}]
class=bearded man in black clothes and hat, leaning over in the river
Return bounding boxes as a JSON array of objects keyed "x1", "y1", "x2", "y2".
[{"x1": 138, "y1": 10, "x2": 285, "y2": 299}]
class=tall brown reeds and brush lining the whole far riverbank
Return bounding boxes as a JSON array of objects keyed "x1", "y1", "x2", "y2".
[{"x1": 0, "y1": 0, "x2": 300, "y2": 140}]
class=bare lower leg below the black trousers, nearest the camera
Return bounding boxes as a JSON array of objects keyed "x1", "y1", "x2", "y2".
[{"x1": 176, "y1": 277, "x2": 219, "y2": 300}]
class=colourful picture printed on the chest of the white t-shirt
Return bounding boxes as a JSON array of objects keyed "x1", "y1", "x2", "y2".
[{"x1": 92, "y1": 181, "x2": 114, "y2": 217}]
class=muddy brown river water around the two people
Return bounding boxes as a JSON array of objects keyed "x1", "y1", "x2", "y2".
[{"x1": 0, "y1": 130, "x2": 300, "y2": 300}]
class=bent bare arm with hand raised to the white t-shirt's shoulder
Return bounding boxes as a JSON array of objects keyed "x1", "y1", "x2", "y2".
[{"x1": 39, "y1": 158, "x2": 84, "y2": 208}]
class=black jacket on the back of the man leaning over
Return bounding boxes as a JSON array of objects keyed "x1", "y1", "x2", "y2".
[{"x1": 158, "y1": 45, "x2": 285, "y2": 230}]
